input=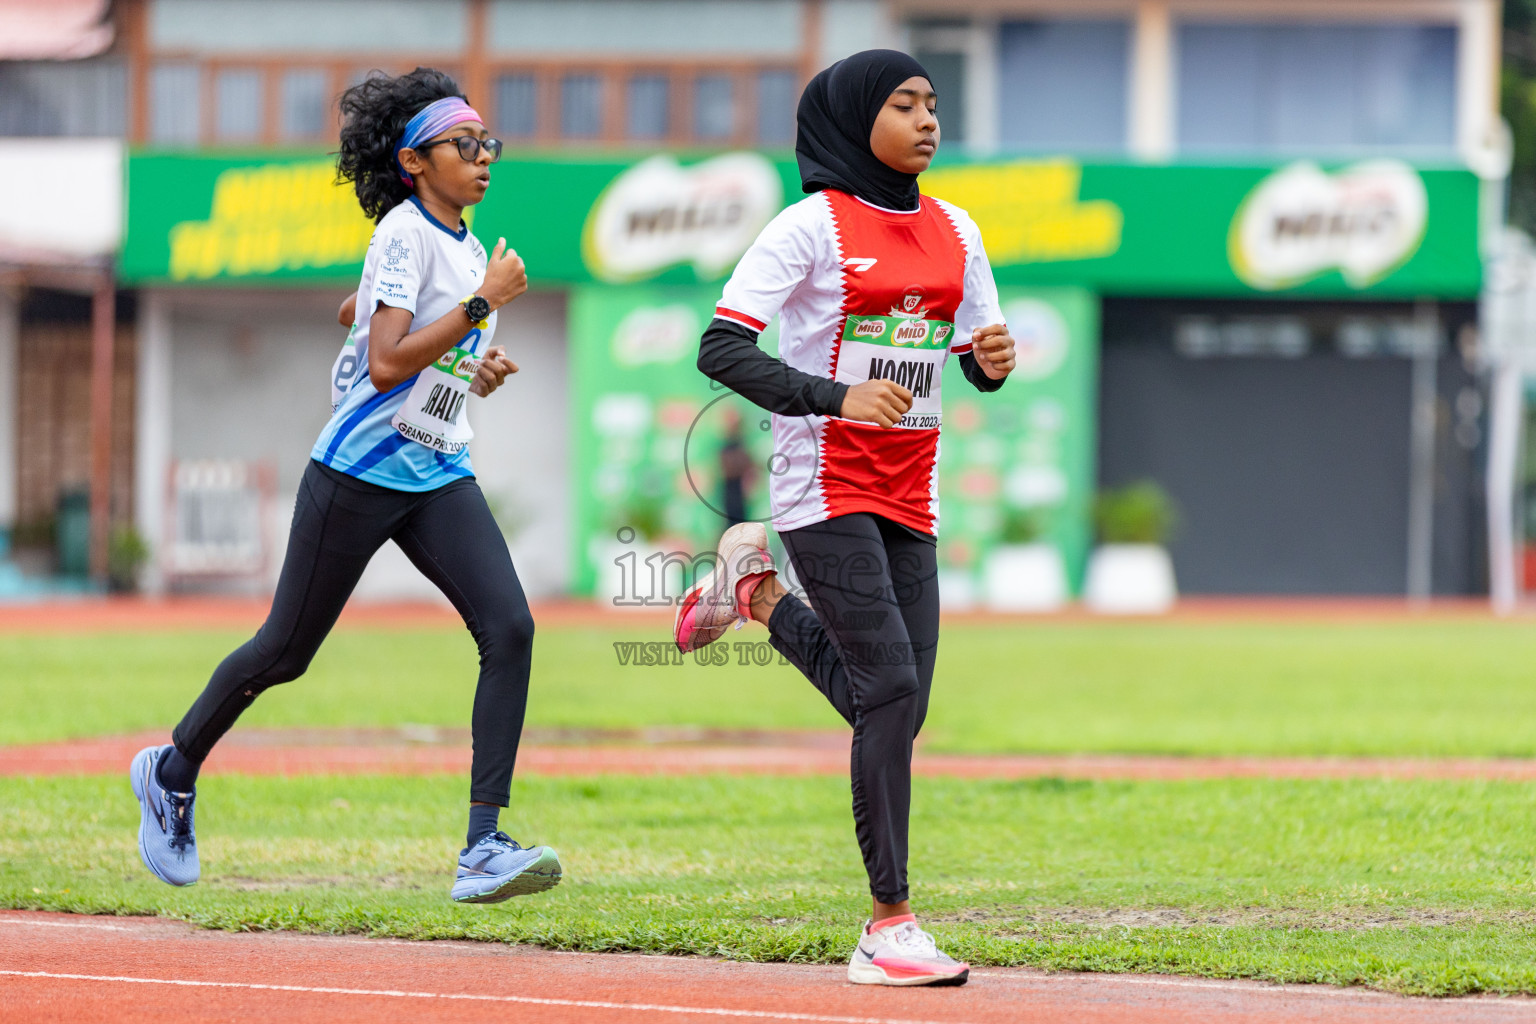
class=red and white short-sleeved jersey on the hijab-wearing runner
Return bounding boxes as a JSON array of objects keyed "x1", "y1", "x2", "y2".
[{"x1": 714, "y1": 190, "x2": 1003, "y2": 534}]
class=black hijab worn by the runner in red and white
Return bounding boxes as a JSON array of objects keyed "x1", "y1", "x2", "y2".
[{"x1": 794, "y1": 49, "x2": 932, "y2": 210}]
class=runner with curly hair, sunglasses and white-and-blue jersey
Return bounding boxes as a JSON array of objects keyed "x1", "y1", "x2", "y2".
[{"x1": 129, "y1": 68, "x2": 561, "y2": 903}]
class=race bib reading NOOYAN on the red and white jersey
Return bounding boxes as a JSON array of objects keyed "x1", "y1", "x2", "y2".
[{"x1": 833, "y1": 316, "x2": 955, "y2": 430}]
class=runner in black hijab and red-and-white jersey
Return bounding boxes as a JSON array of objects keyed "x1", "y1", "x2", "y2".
[{"x1": 674, "y1": 51, "x2": 1014, "y2": 986}]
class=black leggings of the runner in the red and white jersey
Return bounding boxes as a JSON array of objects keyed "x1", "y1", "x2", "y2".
[{"x1": 768, "y1": 513, "x2": 938, "y2": 903}]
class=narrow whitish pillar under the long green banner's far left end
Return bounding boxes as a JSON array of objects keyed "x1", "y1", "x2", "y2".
[{"x1": 134, "y1": 289, "x2": 172, "y2": 594}]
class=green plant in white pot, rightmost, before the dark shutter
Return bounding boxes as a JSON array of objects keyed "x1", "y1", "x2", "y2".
[{"x1": 1083, "y1": 481, "x2": 1178, "y2": 614}]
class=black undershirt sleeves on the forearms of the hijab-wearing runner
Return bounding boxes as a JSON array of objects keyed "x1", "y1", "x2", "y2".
[{"x1": 697, "y1": 318, "x2": 1003, "y2": 416}]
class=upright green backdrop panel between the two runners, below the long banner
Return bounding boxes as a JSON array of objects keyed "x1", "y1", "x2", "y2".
[{"x1": 568, "y1": 286, "x2": 777, "y2": 605}]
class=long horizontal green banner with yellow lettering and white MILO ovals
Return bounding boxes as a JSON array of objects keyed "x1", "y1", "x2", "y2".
[{"x1": 121, "y1": 152, "x2": 1482, "y2": 298}]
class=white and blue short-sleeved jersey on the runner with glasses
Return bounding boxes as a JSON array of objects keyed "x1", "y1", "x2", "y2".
[{"x1": 310, "y1": 197, "x2": 496, "y2": 491}]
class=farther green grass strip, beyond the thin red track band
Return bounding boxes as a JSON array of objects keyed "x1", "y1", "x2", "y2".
[{"x1": 9, "y1": 620, "x2": 1536, "y2": 757}]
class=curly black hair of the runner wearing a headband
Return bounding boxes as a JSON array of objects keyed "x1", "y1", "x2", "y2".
[{"x1": 336, "y1": 68, "x2": 465, "y2": 224}]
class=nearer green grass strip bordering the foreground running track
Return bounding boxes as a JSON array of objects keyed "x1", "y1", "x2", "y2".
[{"x1": 0, "y1": 775, "x2": 1536, "y2": 995}]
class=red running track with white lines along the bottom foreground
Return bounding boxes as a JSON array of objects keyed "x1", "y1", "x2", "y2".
[{"x1": 0, "y1": 910, "x2": 1536, "y2": 1024}]
